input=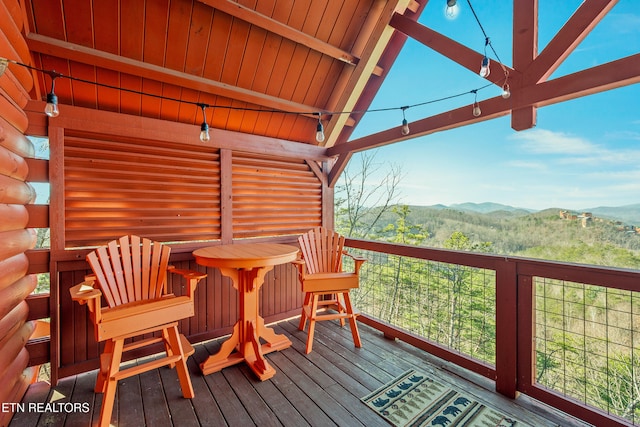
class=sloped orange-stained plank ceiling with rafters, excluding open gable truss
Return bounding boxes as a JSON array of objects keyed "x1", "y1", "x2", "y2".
[{"x1": 25, "y1": 0, "x2": 426, "y2": 146}]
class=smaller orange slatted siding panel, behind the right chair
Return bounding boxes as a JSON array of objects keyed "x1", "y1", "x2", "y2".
[{"x1": 233, "y1": 153, "x2": 322, "y2": 239}]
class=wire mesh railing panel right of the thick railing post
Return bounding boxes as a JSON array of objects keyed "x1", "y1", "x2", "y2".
[{"x1": 535, "y1": 277, "x2": 640, "y2": 425}]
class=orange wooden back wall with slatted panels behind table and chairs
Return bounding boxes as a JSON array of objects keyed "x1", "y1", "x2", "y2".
[{"x1": 39, "y1": 102, "x2": 332, "y2": 382}]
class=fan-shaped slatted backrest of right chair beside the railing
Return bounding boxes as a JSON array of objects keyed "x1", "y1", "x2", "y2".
[{"x1": 298, "y1": 227, "x2": 344, "y2": 274}]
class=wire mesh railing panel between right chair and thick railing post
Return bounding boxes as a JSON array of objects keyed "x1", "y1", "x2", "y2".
[{"x1": 345, "y1": 249, "x2": 496, "y2": 366}]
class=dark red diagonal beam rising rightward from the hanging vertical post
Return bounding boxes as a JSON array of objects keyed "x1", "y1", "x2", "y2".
[{"x1": 514, "y1": 0, "x2": 618, "y2": 85}]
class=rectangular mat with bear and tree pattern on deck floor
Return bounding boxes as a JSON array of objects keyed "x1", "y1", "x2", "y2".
[{"x1": 361, "y1": 370, "x2": 532, "y2": 427}]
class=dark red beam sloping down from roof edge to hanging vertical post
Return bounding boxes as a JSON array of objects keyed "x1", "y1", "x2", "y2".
[{"x1": 389, "y1": 14, "x2": 514, "y2": 86}]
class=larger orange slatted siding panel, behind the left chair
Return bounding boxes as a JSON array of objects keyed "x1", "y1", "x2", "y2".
[{"x1": 64, "y1": 130, "x2": 220, "y2": 248}]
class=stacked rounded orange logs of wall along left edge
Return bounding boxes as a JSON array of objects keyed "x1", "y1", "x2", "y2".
[{"x1": 0, "y1": 1, "x2": 36, "y2": 425}]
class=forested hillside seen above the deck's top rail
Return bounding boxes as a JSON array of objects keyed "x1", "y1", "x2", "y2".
[{"x1": 350, "y1": 205, "x2": 640, "y2": 269}]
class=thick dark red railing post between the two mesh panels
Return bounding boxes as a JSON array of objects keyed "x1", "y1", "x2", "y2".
[{"x1": 496, "y1": 259, "x2": 518, "y2": 399}]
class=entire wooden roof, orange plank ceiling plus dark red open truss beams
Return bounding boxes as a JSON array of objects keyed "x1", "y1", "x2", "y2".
[{"x1": 20, "y1": 0, "x2": 640, "y2": 159}]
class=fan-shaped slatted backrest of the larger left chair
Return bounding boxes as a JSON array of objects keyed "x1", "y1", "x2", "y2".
[{"x1": 87, "y1": 235, "x2": 171, "y2": 307}]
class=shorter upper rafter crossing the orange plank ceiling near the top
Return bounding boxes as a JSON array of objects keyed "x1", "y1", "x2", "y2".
[{"x1": 199, "y1": 0, "x2": 359, "y2": 65}]
